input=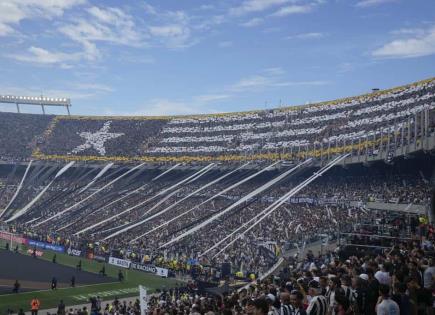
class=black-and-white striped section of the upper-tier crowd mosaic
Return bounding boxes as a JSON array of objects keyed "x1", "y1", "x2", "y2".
[{"x1": 150, "y1": 82, "x2": 435, "y2": 155}]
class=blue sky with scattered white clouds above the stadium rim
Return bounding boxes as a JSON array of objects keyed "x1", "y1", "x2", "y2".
[{"x1": 0, "y1": 0, "x2": 435, "y2": 115}]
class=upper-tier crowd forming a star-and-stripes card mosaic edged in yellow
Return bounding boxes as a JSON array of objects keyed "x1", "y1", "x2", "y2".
[{"x1": 0, "y1": 80, "x2": 435, "y2": 162}]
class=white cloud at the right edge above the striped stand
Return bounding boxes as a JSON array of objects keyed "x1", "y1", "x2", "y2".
[{"x1": 372, "y1": 26, "x2": 435, "y2": 58}]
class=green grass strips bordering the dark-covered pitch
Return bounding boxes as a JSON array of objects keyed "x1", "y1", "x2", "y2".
[{"x1": 0, "y1": 246, "x2": 177, "y2": 314}]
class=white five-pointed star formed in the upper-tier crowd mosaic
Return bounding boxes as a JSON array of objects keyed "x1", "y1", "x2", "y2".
[{"x1": 71, "y1": 121, "x2": 125, "y2": 155}]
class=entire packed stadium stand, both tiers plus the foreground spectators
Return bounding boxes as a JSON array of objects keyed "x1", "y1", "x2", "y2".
[{"x1": 0, "y1": 79, "x2": 435, "y2": 315}]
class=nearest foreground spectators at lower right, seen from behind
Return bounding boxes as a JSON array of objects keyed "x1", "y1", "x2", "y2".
[{"x1": 144, "y1": 239, "x2": 435, "y2": 315}]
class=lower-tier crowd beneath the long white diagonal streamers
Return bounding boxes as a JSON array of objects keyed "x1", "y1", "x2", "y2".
[{"x1": 0, "y1": 156, "x2": 433, "y2": 274}]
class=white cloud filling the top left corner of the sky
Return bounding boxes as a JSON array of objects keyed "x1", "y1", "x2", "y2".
[{"x1": 0, "y1": 0, "x2": 86, "y2": 36}]
